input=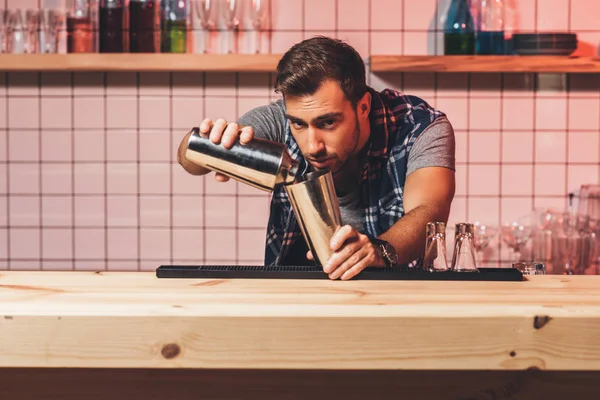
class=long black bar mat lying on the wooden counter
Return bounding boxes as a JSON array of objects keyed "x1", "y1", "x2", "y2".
[{"x1": 156, "y1": 265, "x2": 523, "y2": 282}]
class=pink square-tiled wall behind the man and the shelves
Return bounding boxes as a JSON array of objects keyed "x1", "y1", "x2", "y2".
[{"x1": 0, "y1": 0, "x2": 600, "y2": 270}]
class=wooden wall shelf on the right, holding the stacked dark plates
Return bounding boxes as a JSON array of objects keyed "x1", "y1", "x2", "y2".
[{"x1": 371, "y1": 55, "x2": 600, "y2": 73}]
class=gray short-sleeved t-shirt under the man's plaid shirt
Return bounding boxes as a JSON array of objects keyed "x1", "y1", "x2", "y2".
[{"x1": 238, "y1": 100, "x2": 455, "y2": 232}]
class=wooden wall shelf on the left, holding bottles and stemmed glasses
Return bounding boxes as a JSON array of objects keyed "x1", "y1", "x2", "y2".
[{"x1": 0, "y1": 53, "x2": 281, "y2": 72}]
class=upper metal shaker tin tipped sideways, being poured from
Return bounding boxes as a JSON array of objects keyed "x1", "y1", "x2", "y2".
[{"x1": 185, "y1": 128, "x2": 299, "y2": 192}]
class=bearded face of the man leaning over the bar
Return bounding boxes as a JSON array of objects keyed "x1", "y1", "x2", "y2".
[{"x1": 285, "y1": 81, "x2": 370, "y2": 173}]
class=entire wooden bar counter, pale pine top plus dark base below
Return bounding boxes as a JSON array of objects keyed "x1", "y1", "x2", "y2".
[{"x1": 0, "y1": 271, "x2": 600, "y2": 400}]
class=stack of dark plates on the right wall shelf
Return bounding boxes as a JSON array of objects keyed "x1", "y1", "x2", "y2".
[{"x1": 512, "y1": 32, "x2": 577, "y2": 56}]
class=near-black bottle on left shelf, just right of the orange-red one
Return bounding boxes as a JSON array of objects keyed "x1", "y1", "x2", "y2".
[{"x1": 99, "y1": 0, "x2": 129, "y2": 53}]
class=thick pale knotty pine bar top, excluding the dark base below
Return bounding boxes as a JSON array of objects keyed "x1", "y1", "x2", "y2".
[{"x1": 0, "y1": 271, "x2": 600, "y2": 370}]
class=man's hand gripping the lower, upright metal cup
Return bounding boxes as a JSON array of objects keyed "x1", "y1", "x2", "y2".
[{"x1": 306, "y1": 225, "x2": 385, "y2": 280}]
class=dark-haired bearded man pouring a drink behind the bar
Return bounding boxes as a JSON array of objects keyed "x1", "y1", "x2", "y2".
[{"x1": 178, "y1": 37, "x2": 455, "y2": 280}]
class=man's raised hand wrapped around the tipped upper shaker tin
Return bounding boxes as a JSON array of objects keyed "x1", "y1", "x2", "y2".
[{"x1": 177, "y1": 118, "x2": 254, "y2": 182}]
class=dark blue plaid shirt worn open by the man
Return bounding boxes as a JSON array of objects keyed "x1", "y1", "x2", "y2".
[{"x1": 265, "y1": 89, "x2": 444, "y2": 265}]
